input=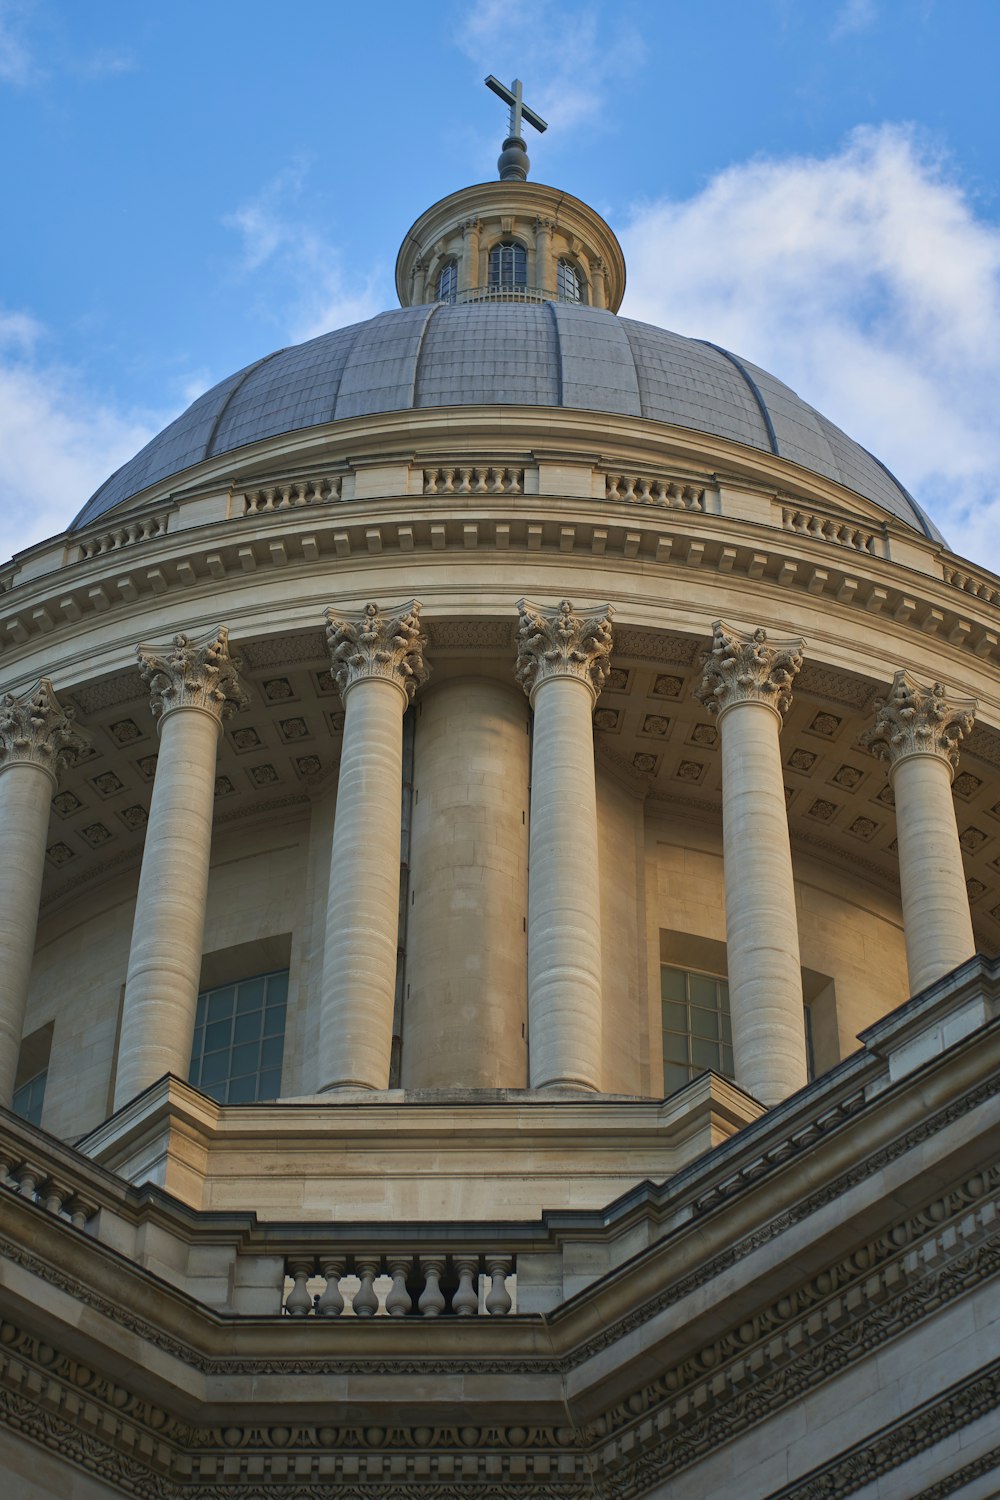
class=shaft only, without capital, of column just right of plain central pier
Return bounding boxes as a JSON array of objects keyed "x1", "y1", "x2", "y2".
[{"x1": 528, "y1": 677, "x2": 601, "y2": 1089}]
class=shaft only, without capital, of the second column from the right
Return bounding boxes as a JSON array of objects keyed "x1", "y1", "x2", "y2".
[{"x1": 720, "y1": 701, "x2": 807, "y2": 1104}]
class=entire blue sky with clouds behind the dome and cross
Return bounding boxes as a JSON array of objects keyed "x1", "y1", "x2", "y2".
[{"x1": 0, "y1": 0, "x2": 1000, "y2": 569}]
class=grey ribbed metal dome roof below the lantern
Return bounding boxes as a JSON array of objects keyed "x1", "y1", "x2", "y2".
[{"x1": 70, "y1": 302, "x2": 942, "y2": 540}]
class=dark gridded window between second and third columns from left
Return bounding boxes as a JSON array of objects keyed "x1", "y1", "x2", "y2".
[{"x1": 189, "y1": 969, "x2": 288, "y2": 1104}]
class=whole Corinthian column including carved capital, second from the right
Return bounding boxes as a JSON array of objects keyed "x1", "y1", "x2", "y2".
[{"x1": 696, "y1": 620, "x2": 807, "y2": 1104}]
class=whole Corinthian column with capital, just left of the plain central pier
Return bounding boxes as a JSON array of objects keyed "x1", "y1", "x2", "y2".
[{"x1": 319, "y1": 600, "x2": 429, "y2": 1089}]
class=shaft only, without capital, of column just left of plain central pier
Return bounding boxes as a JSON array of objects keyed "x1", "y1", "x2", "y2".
[{"x1": 319, "y1": 677, "x2": 406, "y2": 1089}]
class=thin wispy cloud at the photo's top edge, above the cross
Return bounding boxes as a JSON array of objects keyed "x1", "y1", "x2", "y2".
[{"x1": 457, "y1": 0, "x2": 645, "y2": 129}]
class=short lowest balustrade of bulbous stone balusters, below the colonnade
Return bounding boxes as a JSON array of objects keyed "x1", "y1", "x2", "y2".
[{"x1": 282, "y1": 1250, "x2": 517, "y2": 1317}]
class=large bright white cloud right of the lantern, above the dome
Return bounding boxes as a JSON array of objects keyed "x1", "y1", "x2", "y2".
[{"x1": 622, "y1": 126, "x2": 1000, "y2": 572}]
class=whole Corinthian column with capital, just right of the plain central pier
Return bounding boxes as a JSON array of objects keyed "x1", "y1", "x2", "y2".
[{"x1": 514, "y1": 599, "x2": 613, "y2": 1089}]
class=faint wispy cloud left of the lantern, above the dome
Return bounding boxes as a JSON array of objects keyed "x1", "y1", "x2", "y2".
[{"x1": 223, "y1": 162, "x2": 393, "y2": 342}]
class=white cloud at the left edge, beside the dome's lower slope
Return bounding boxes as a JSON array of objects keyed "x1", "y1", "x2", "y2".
[{"x1": 0, "y1": 322, "x2": 164, "y2": 558}]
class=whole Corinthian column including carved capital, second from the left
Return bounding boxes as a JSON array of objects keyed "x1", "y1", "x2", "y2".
[{"x1": 114, "y1": 626, "x2": 249, "y2": 1109}]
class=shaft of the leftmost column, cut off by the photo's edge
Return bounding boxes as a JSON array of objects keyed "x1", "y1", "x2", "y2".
[{"x1": 0, "y1": 761, "x2": 55, "y2": 1109}]
